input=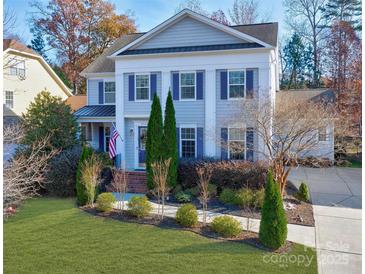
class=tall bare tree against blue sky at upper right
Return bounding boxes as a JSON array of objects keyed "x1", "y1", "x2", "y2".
[{"x1": 284, "y1": 0, "x2": 327, "y2": 87}]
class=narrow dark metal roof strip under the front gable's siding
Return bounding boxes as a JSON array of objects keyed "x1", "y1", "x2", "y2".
[{"x1": 118, "y1": 43, "x2": 263, "y2": 55}]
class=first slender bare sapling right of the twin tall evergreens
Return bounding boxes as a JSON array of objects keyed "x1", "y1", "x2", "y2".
[{"x1": 196, "y1": 164, "x2": 213, "y2": 226}]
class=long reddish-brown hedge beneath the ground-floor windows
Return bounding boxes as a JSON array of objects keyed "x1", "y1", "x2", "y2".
[{"x1": 178, "y1": 159, "x2": 268, "y2": 189}]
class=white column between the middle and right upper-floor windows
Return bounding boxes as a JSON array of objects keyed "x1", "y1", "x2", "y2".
[{"x1": 204, "y1": 69, "x2": 217, "y2": 157}]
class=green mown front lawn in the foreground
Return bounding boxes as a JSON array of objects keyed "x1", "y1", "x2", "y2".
[{"x1": 4, "y1": 198, "x2": 317, "y2": 274}]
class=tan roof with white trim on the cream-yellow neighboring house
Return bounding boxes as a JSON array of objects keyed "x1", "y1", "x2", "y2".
[{"x1": 3, "y1": 39, "x2": 73, "y2": 96}]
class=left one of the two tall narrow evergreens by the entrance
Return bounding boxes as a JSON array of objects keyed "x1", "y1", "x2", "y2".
[{"x1": 146, "y1": 94, "x2": 163, "y2": 189}]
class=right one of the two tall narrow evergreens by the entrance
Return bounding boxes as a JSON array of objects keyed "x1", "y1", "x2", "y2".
[{"x1": 163, "y1": 91, "x2": 178, "y2": 188}]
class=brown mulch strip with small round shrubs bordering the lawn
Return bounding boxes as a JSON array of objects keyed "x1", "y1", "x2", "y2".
[{"x1": 80, "y1": 206, "x2": 294, "y2": 254}]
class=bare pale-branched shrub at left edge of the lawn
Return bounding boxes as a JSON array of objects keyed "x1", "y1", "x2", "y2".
[{"x1": 3, "y1": 136, "x2": 59, "y2": 216}]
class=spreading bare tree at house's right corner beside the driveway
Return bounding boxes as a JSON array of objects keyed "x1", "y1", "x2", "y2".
[{"x1": 236, "y1": 92, "x2": 337, "y2": 195}]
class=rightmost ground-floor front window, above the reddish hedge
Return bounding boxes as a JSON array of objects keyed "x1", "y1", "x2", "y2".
[{"x1": 228, "y1": 128, "x2": 245, "y2": 160}]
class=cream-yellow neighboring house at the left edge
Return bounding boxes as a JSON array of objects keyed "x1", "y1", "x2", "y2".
[{"x1": 3, "y1": 39, "x2": 72, "y2": 123}]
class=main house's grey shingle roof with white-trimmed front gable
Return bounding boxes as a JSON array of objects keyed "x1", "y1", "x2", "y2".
[{"x1": 81, "y1": 9, "x2": 278, "y2": 76}]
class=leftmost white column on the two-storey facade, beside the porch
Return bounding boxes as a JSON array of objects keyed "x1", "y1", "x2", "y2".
[{"x1": 115, "y1": 70, "x2": 127, "y2": 169}]
